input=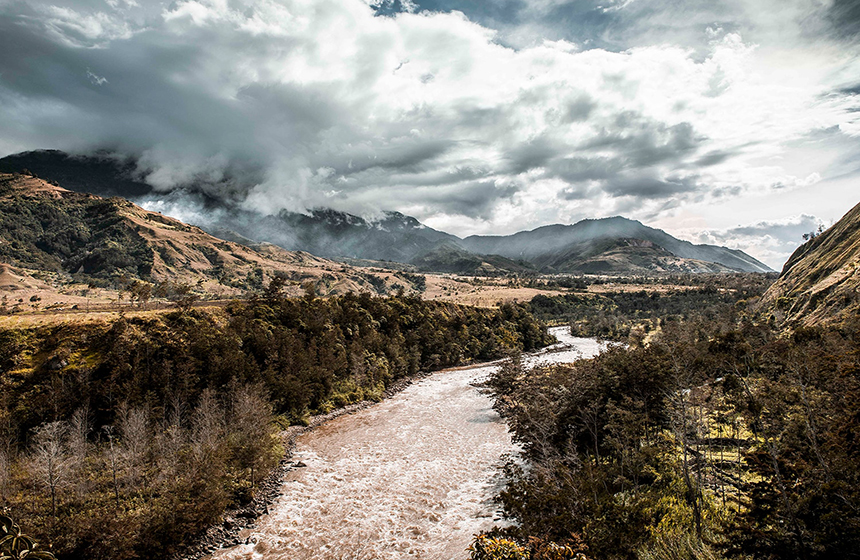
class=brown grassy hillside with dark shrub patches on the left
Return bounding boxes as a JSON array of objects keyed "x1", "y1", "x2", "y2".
[{"x1": 0, "y1": 174, "x2": 402, "y2": 295}]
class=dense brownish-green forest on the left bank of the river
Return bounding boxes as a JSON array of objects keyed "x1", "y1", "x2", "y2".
[{"x1": 0, "y1": 290, "x2": 550, "y2": 560}]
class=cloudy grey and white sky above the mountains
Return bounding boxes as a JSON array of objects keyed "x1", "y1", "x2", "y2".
[{"x1": 0, "y1": 0, "x2": 860, "y2": 269}]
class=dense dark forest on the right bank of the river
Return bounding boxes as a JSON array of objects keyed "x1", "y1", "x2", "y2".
[{"x1": 472, "y1": 305, "x2": 860, "y2": 560}]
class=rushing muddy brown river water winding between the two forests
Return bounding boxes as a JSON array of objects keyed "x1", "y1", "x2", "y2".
[{"x1": 208, "y1": 327, "x2": 600, "y2": 560}]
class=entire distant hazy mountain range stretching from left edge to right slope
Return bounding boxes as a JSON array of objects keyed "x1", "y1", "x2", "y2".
[{"x1": 0, "y1": 151, "x2": 771, "y2": 274}]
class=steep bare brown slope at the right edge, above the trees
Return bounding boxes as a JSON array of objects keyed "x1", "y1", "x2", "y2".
[{"x1": 759, "y1": 199, "x2": 860, "y2": 325}]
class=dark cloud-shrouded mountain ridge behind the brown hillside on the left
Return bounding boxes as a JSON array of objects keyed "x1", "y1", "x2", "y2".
[{"x1": 0, "y1": 150, "x2": 459, "y2": 263}]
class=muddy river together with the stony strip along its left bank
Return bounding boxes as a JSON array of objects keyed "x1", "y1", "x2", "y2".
[{"x1": 177, "y1": 328, "x2": 599, "y2": 560}]
